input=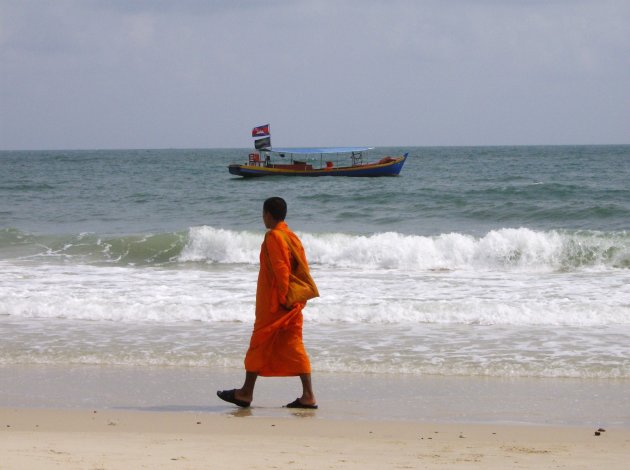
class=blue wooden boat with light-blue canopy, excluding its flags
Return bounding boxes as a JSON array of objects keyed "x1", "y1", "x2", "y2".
[{"x1": 228, "y1": 147, "x2": 408, "y2": 178}]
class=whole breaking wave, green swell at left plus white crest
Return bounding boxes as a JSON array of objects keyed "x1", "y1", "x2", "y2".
[{"x1": 0, "y1": 226, "x2": 630, "y2": 271}]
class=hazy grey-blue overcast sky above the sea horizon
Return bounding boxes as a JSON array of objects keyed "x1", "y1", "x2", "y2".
[{"x1": 0, "y1": 0, "x2": 630, "y2": 149}]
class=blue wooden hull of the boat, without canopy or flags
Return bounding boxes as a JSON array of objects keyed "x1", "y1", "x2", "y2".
[{"x1": 228, "y1": 154, "x2": 407, "y2": 178}]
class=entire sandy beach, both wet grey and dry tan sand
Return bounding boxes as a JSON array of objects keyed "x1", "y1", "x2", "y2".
[{"x1": 0, "y1": 366, "x2": 630, "y2": 470}]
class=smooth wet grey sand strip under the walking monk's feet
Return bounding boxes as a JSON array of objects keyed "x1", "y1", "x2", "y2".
[{"x1": 0, "y1": 365, "x2": 630, "y2": 428}]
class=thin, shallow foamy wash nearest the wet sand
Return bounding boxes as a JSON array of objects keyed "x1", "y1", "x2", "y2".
[{"x1": 0, "y1": 317, "x2": 630, "y2": 379}]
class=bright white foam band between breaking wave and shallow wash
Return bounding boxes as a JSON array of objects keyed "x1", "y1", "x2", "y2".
[{"x1": 0, "y1": 262, "x2": 630, "y2": 326}]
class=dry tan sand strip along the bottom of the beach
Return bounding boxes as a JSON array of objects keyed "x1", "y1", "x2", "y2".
[{"x1": 0, "y1": 408, "x2": 630, "y2": 470}]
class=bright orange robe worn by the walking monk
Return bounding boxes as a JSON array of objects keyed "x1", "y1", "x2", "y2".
[{"x1": 245, "y1": 222, "x2": 311, "y2": 377}]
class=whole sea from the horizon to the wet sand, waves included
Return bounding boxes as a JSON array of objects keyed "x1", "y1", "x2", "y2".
[{"x1": 0, "y1": 145, "x2": 630, "y2": 380}]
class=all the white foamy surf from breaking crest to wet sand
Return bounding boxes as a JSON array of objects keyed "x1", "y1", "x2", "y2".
[{"x1": 0, "y1": 227, "x2": 630, "y2": 378}]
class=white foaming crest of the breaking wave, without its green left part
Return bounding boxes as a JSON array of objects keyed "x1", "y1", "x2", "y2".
[{"x1": 179, "y1": 227, "x2": 630, "y2": 271}]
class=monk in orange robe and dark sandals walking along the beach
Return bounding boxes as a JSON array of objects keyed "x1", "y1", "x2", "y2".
[{"x1": 217, "y1": 197, "x2": 317, "y2": 409}]
